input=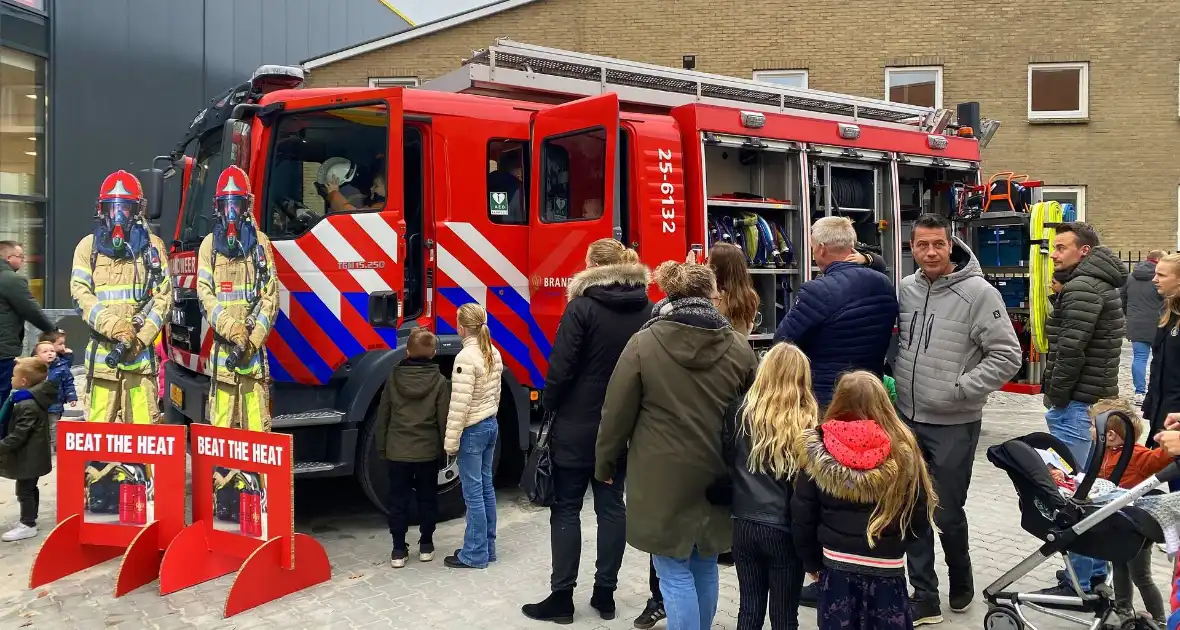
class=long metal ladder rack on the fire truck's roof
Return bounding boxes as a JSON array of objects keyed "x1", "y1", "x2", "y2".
[{"x1": 422, "y1": 39, "x2": 946, "y2": 131}]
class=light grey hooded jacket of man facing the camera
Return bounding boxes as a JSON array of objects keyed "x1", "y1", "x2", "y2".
[{"x1": 893, "y1": 238, "x2": 1021, "y2": 425}]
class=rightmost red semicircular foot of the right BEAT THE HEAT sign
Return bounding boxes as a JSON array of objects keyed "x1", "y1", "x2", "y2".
[{"x1": 225, "y1": 533, "x2": 332, "y2": 617}]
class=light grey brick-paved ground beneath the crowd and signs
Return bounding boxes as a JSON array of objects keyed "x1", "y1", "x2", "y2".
[{"x1": 0, "y1": 355, "x2": 1169, "y2": 630}]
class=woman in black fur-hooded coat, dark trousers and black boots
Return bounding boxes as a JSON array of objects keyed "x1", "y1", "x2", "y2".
[{"x1": 522, "y1": 238, "x2": 651, "y2": 623}]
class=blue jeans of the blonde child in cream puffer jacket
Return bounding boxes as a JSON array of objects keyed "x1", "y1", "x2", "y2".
[{"x1": 459, "y1": 415, "x2": 500, "y2": 569}]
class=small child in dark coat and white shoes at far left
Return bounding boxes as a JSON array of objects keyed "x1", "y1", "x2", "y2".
[{"x1": 0, "y1": 356, "x2": 58, "y2": 543}]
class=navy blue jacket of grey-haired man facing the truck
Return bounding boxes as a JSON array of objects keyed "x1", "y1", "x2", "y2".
[{"x1": 774, "y1": 262, "x2": 897, "y2": 406}]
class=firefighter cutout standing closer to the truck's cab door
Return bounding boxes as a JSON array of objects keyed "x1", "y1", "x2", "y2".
[{"x1": 197, "y1": 166, "x2": 278, "y2": 431}]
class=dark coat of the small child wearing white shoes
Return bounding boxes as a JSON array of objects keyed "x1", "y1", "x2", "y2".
[{"x1": 0, "y1": 381, "x2": 58, "y2": 479}]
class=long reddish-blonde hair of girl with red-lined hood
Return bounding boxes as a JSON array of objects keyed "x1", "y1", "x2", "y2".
[{"x1": 824, "y1": 370, "x2": 938, "y2": 546}]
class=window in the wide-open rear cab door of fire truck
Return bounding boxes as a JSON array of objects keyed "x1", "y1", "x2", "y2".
[{"x1": 540, "y1": 127, "x2": 615, "y2": 223}]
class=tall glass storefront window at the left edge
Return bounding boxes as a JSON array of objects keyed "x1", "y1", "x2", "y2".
[{"x1": 0, "y1": 0, "x2": 48, "y2": 303}]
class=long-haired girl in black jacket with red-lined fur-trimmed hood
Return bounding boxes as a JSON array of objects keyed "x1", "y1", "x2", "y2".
[{"x1": 791, "y1": 370, "x2": 937, "y2": 630}]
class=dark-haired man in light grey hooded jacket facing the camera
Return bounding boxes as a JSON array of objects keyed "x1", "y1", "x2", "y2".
[{"x1": 893, "y1": 215, "x2": 1021, "y2": 625}]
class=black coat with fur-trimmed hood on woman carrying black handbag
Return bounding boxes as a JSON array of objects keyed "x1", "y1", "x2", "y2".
[{"x1": 543, "y1": 264, "x2": 651, "y2": 468}]
